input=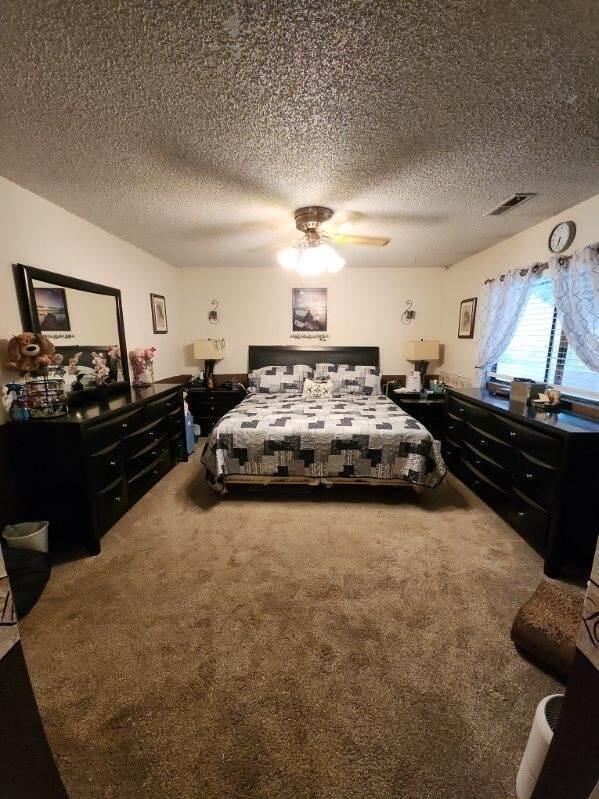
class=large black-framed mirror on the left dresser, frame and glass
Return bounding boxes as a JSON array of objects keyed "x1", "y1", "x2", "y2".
[{"x1": 13, "y1": 264, "x2": 129, "y2": 399}]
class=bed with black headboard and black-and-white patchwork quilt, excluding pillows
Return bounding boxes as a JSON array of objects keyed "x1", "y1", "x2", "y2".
[{"x1": 202, "y1": 346, "x2": 446, "y2": 491}]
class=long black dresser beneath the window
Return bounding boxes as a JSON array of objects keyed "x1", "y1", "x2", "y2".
[{"x1": 443, "y1": 389, "x2": 599, "y2": 577}]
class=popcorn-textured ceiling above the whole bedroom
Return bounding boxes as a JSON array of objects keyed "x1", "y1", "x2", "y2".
[{"x1": 0, "y1": 0, "x2": 599, "y2": 266}]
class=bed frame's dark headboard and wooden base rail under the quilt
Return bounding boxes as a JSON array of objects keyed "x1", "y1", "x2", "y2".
[{"x1": 218, "y1": 345, "x2": 420, "y2": 491}]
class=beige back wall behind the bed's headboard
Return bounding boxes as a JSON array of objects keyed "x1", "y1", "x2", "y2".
[{"x1": 182, "y1": 265, "x2": 443, "y2": 373}]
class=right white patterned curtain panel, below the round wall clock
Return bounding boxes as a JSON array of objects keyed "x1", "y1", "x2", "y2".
[{"x1": 549, "y1": 244, "x2": 599, "y2": 372}]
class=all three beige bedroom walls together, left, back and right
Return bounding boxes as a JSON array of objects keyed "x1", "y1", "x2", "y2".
[{"x1": 0, "y1": 178, "x2": 599, "y2": 400}]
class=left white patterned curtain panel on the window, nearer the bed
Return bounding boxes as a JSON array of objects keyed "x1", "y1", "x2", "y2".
[{"x1": 474, "y1": 265, "x2": 539, "y2": 388}]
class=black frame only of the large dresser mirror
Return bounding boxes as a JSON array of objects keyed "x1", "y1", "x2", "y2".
[{"x1": 13, "y1": 264, "x2": 130, "y2": 397}]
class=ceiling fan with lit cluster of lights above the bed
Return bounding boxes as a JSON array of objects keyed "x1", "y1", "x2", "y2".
[{"x1": 278, "y1": 205, "x2": 390, "y2": 275}]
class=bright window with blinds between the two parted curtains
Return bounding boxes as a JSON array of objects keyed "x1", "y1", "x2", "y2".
[{"x1": 494, "y1": 277, "x2": 599, "y2": 400}]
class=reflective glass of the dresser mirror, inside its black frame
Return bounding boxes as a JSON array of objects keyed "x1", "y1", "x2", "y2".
[{"x1": 32, "y1": 278, "x2": 124, "y2": 392}]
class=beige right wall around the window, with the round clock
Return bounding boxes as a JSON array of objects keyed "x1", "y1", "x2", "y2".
[{"x1": 440, "y1": 195, "x2": 599, "y2": 380}]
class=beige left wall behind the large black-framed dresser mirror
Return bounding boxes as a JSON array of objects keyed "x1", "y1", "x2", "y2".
[{"x1": 0, "y1": 178, "x2": 184, "y2": 396}]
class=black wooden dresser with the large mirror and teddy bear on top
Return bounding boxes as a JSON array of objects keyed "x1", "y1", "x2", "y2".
[{"x1": 9, "y1": 384, "x2": 187, "y2": 554}]
